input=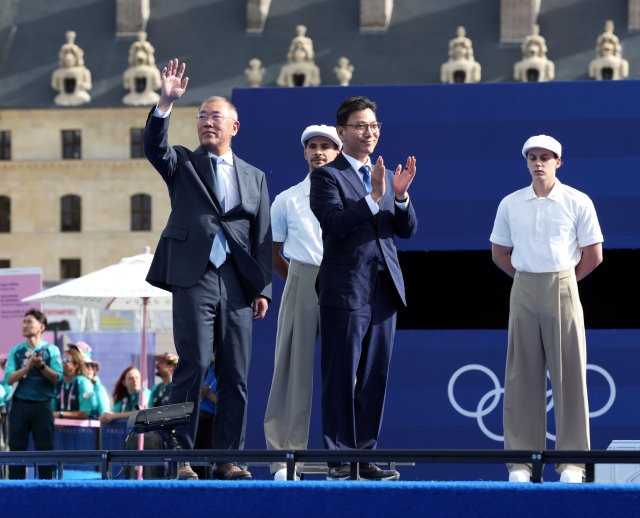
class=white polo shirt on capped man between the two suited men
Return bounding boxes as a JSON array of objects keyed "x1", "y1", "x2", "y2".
[{"x1": 271, "y1": 175, "x2": 323, "y2": 265}]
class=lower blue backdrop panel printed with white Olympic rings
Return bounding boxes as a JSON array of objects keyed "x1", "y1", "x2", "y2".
[{"x1": 246, "y1": 328, "x2": 640, "y2": 480}]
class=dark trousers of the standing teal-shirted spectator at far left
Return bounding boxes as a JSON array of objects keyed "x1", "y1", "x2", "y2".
[{"x1": 9, "y1": 397, "x2": 55, "y2": 479}]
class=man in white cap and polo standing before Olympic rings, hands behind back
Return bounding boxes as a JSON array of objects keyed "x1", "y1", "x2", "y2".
[{"x1": 490, "y1": 135, "x2": 603, "y2": 483}]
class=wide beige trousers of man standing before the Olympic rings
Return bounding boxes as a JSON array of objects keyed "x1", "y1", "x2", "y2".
[{"x1": 503, "y1": 268, "x2": 590, "y2": 476}]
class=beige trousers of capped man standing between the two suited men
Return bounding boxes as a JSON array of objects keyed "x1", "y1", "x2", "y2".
[{"x1": 264, "y1": 260, "x2": 320, "y2": 474}]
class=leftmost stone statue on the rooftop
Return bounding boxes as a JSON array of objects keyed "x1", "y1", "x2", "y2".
[{"x1": 51, "y1": 31, "x2": 91, "y2": 106}]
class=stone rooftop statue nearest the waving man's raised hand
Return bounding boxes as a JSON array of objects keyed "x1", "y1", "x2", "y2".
[{"x1": 122, "y1": 32, "x2": 161, "y2": 106}]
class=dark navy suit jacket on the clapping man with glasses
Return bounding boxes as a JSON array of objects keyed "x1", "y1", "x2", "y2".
[{"x1": 310, "y1": 155, "x2": 418, "y2": 309}]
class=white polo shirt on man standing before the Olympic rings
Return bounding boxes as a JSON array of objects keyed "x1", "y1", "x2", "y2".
[{"x1": 489, "y1": 178, "x2": 604, "y2": 273}]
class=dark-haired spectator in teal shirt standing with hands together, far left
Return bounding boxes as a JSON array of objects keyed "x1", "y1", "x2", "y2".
[{"x1": 5, "y1": 309, "x2": 62, "y2": 479}]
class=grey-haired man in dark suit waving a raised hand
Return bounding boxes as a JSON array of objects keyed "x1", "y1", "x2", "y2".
[{"x1": 144, "y1": 59, "x2": 273, "y2": 480}]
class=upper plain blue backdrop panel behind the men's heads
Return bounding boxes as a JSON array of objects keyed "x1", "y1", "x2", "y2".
[{"x1": 233, "y1": 81, "x2": 640, "y2": 250}]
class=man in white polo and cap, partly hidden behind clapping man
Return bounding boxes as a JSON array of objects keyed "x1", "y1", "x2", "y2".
[{"x1": 264, "y1": 125, "x2": 342, "y2": 480}]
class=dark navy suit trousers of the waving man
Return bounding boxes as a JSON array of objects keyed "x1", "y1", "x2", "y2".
[{"x1": 169, "y1": 262, "x2": 253, "y2": 450}]
